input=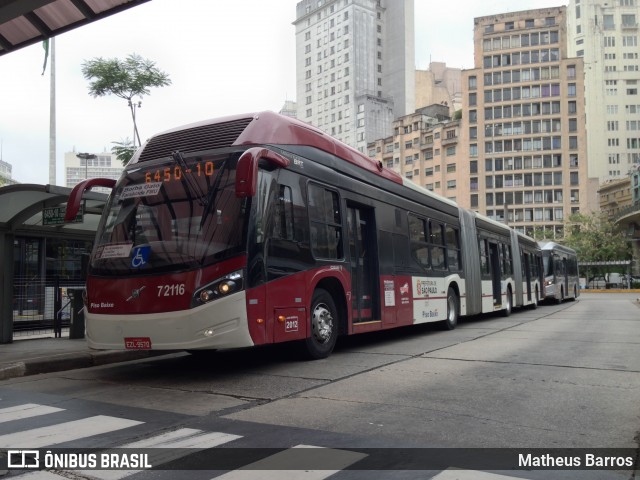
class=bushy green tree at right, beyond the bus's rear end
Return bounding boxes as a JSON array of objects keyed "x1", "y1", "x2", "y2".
[{"x1": 562, "y1": 213, "x2": 631, "y2": 262}]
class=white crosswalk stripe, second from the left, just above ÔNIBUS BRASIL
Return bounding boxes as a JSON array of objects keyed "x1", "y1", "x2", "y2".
[{"x1": 0, "y1": 415, "x2": 144, "y2": 448}]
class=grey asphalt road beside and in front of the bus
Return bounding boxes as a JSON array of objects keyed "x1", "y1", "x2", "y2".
[{"x1": 0, "y1": 293, "x2": 640, "y2": 480}]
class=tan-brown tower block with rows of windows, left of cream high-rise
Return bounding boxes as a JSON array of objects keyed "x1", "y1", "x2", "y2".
[{"x1": 457, "y1": 7, "x2": 597, "y2": 238}]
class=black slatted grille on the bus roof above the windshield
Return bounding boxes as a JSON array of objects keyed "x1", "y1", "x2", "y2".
[{"x1": 138, "y1": 117, "x2": 253, "y2": 162}]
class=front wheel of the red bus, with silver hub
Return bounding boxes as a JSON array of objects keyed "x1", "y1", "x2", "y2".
[{"x1": 303, "y1": 289, "x2": 339, "y2": 360}]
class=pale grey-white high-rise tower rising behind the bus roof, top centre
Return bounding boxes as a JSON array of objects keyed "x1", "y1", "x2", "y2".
[{"x1": 294, "y1": 0, "x2": 415, "y2": 152}]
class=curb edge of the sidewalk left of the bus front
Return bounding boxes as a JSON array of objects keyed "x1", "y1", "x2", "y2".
[{"x1": 0, "y1": 350, "x2": 165, "y2": 380}]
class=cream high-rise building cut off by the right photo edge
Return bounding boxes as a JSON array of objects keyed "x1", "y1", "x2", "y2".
[{"x1": 567, "y1": 0, "x2": 640, "y2": 182}]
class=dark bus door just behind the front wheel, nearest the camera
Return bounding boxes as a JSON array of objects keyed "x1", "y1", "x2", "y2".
[{"x1": 347, "y1": 205, "x2": 378, "y2": 323}]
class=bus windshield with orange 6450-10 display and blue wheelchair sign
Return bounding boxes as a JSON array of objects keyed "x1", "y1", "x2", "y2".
[{"x1": 91, "y1": 152, "x2": 250, "y2": 275}]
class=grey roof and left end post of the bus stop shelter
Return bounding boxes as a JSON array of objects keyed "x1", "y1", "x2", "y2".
[{"x1": 0, "y1": 184, "x2": 108, "y2": 343}]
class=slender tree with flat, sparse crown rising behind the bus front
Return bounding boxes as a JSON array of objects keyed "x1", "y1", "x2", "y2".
[{"x1": 82, "y1": 53, "x2": 171, "y2": 149}]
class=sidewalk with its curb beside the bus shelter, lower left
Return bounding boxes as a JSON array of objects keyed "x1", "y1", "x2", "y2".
[{"x1": 0, "y1": 334, "x2": 165, "y2": 380}]
